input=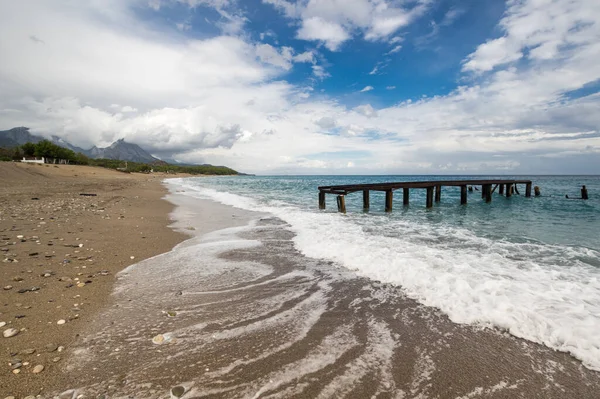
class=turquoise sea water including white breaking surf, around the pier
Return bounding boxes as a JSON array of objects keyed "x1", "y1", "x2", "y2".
[{"x1": 169, "y1": 176, "x2": 600, "y2": 370}]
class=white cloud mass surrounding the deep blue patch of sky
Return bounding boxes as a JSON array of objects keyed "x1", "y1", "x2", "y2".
[{"x1": 0, "y1": 0, "x2": 600, "y2": 173}]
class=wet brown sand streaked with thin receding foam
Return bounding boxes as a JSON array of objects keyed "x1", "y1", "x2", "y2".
[{"x1": 49, "y1": 189, "x2": 600, "y2": 398}]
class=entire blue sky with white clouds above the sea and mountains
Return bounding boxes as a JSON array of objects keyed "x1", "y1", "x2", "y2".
[{"x1": 0, "y1": 0, "x2": 600, "y2": 174}]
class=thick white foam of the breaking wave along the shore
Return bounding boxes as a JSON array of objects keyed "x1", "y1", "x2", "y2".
[{"x1": 165, "y1": 180, "x2": 600, "y2": 370}]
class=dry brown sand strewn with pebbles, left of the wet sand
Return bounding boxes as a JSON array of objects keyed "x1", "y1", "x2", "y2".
[{"x1": 0, "y1": 163, "x2": 185, "y2": 398}]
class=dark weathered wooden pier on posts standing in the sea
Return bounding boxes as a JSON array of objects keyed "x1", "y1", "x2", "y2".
[{"x1": 319, "y1": 179, "x2": 532, "y2": 213}]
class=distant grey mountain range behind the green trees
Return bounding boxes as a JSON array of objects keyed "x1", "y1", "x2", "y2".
[{"x1": 0, "y1": 127, "x2": 161, "y2": 163}]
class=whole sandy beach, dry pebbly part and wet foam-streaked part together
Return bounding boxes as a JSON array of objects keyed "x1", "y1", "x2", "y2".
[{"x1": 0, "y1": 164, "x2": 600, "y2": 399}]
